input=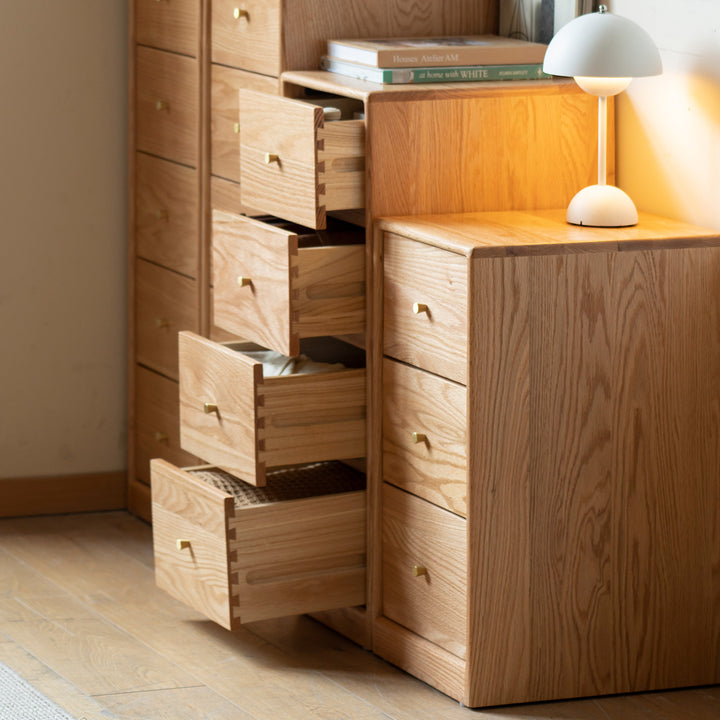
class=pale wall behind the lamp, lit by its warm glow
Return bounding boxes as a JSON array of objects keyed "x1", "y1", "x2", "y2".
[{"x1": 607, "y1": 0, "x2": 720, "y2": 229}]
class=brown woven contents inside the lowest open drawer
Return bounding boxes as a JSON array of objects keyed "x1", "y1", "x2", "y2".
[{"x1": 192, "y1": 462, "x2": 365, "y2": 508}]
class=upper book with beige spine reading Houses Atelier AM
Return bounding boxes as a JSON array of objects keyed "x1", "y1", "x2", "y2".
[{"x1": 327, "y1": 35, "x2": 547, "y2": 68}]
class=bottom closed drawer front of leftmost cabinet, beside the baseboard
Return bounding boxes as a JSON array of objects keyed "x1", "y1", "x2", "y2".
[{"x1": 135, "y1": 365, "x2": 199, "y2": 485}]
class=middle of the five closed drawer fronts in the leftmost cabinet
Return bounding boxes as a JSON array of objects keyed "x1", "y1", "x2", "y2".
[{"x1": 135, "y1": 153, "x2": 199, "y2": 278}]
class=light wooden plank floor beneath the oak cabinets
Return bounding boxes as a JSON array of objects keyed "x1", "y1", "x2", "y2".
[{"x1": 0, "y1": 513, "x2": 720, "y2": 720}]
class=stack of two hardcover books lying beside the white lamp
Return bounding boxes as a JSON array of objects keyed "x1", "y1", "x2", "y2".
[{"x1": 322, "y1": 35, "x2": 550, "y2": 83}]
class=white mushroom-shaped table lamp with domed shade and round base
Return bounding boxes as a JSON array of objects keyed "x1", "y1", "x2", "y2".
[{"x1": 543, "y1": 5, "x2": 662, "y2": 227}]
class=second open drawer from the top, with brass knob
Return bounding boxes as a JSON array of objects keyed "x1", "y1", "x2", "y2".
[{"x1": 213, "y1": 210, "x2": 365, "y2": 355}]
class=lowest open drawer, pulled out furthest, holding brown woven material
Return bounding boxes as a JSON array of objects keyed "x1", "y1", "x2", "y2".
[{"x1": 152, "y1": 460, "x2": 365, "y2": 629}]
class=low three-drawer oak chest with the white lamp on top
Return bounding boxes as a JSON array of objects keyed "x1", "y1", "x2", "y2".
[{"x1": 374, "y1": 211, "x2": 720, "y2": 706}]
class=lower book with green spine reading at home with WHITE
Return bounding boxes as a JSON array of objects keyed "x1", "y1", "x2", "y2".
[{"x1": 321, "y1": 56, "x2": 552, "y2": 84}]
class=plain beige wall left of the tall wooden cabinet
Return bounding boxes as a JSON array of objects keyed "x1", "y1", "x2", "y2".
[{"x1": 0, "y1": 0, "x2": 127, "y2": 478}]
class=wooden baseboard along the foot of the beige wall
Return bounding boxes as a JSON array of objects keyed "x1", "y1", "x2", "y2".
[{"x1": 0, "y1": 471, "x2": 127, "y2": 517}]
